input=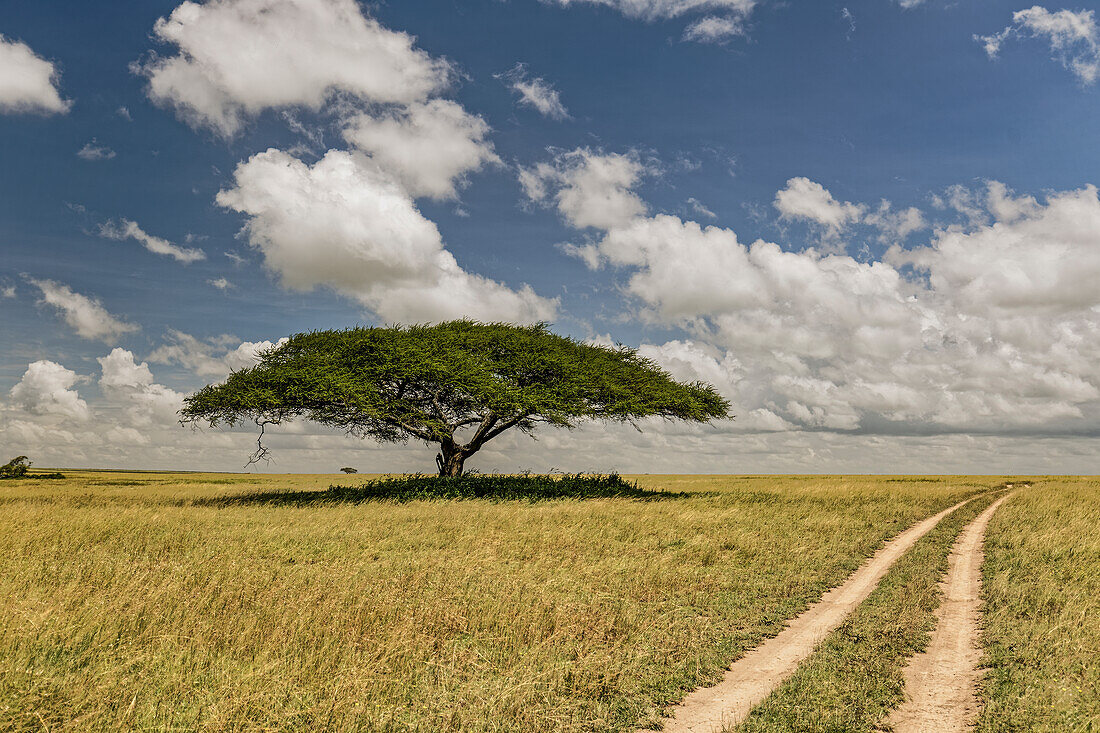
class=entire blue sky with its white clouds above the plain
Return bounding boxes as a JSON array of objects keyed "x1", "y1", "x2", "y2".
[{"x1": 0, "y1": 0, "x2": 1100, "y2": 473}]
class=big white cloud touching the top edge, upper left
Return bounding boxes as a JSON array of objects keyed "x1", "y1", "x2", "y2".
[{"x1": 134, "y1": 0, "x2": 452, "y2": 135}]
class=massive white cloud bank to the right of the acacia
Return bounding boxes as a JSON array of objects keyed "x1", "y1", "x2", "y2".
[{"x1": 527, "y1": 150, "x2": 1100, "y2": 435}]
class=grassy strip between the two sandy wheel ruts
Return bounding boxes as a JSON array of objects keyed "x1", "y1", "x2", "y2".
[{"x1": 733, "y1": 488, "x2": 993, "y2": 733}]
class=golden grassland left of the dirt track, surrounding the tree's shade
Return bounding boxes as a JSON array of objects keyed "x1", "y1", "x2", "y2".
[{"x1": 0, "y1": 472, "x2": 1047, "y2": 731}]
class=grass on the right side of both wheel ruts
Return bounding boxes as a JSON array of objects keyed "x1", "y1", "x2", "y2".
[{"x1": 977, "y1": 478, "x2": 1100, "y2": 733}]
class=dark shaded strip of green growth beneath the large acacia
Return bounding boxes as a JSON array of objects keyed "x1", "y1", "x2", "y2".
[{"x1": 200, "y1": 473, "x2": 677, "y2": 505}]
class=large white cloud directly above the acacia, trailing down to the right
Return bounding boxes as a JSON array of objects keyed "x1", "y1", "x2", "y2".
[{"x1": 217, "y1": 149, "x2": 557, "y2": 321}]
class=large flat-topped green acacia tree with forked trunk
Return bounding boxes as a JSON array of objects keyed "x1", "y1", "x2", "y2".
[{"x1": 180, "y1": 320, "x2": 729, "y2": 477}]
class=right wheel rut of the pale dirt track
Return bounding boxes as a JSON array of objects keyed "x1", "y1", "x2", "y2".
[{"x1": 890, "y1": 496, "x2": 1008, "y2": 733}]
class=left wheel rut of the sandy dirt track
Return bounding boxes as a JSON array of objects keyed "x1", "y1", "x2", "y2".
[{"x1": 646, "y1": 493, "x2": 966, "y2": 733}]
